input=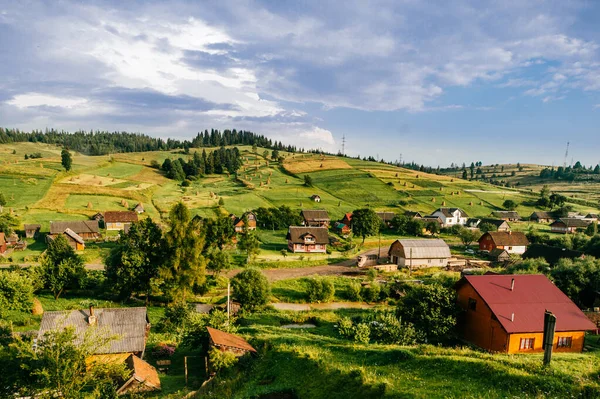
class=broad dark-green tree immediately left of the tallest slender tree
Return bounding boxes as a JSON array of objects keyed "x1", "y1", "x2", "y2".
[{"x1": 105, "y1": 218, "x2": 166, "y2": 304}]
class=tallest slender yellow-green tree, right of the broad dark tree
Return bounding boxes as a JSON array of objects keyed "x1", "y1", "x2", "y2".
[{"x1": 160, "y1": 202, "x2": 206, "y2": 300}]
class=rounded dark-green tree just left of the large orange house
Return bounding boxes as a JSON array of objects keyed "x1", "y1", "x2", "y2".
[{"x1": 396, "y1": 284, "x2": 458, "y2": 344}]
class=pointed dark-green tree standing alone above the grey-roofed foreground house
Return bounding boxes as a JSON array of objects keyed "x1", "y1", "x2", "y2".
[{"x1": 40, "y1": 234, "x2": 85, "y2": 299}]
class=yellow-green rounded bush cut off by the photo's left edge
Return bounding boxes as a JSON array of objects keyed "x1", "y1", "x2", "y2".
[{"x1": 0, "y1": 271, "x2": 33, "y2": 312}]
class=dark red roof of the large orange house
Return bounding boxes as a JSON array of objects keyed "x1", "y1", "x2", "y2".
[{"x1": 456, "y1": 274, "x2": 596, "y2": 334}]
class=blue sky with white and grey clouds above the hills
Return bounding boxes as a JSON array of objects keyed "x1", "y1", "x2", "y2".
[{"x1": 0, "y1": 0, "x2": 600, "y2": 167}]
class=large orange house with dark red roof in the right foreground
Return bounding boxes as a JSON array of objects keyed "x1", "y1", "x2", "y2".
[{"x1": 455, "y1": 274, "x2": 596, "y2": 353}]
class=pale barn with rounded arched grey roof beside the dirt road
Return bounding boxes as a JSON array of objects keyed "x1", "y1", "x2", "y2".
[{"x1": 388, "y1": 239, "x2": 450, "y2": 268}]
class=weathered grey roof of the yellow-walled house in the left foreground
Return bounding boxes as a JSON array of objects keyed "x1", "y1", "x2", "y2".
[{"x1": 38, "y1": 307, "x2": 149, "y2": 354}]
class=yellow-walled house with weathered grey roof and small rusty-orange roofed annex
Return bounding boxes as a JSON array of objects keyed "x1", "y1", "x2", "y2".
[{"x1": 37, "y1": 306, "x2": 160, "y2": 393}]
